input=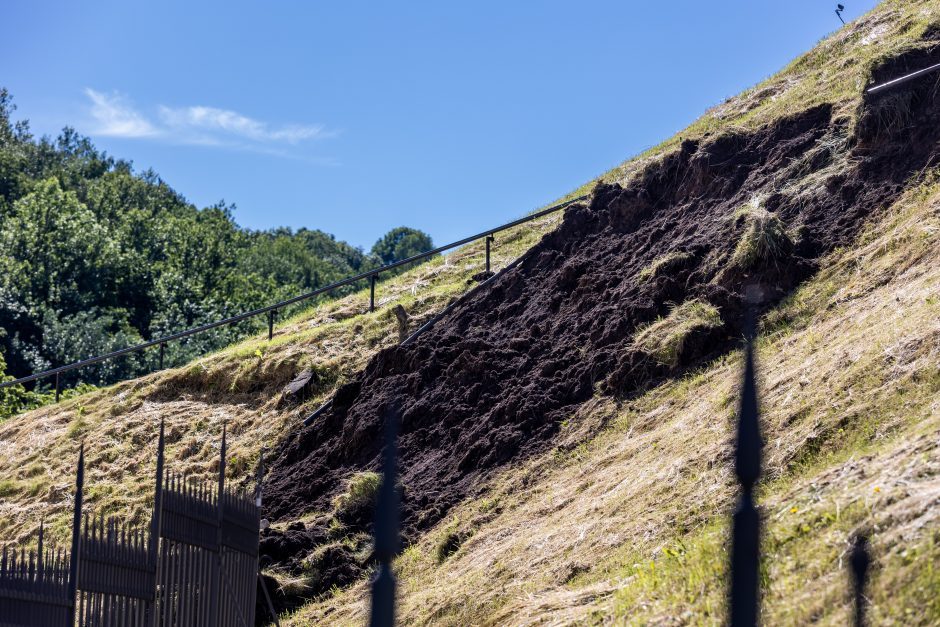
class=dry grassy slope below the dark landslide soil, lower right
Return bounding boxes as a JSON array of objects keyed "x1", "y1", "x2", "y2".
[{"x1": 288, "y1": 174, "x2": 940, "y2": 625}]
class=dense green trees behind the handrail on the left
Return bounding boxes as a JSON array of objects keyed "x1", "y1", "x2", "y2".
[{"x1": 0, "y1": 89, "x2": 432, "y2": 413}]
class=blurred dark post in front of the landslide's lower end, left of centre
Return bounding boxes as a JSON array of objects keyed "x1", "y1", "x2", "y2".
[{"x1": 369, "y1": 408, "x2": 399, "y2": 627}]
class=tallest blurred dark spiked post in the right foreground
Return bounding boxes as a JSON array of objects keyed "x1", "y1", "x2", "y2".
[{"x1": 730, "y1": 303, "x2": 761, "y2": 627}]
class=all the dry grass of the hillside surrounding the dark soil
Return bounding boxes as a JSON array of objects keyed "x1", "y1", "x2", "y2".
[{"x1": 0, "y1": 0, "x2": 940, "y2": 625}]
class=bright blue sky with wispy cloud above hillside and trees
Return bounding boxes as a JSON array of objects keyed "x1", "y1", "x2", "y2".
[{"x1": 0, "y1": 0, "x2": 876, "y2": 248}]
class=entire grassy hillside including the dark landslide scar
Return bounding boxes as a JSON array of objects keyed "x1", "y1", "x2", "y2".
[{"x1": 0, "y1": 0, "x2": 940, "y2": 625}]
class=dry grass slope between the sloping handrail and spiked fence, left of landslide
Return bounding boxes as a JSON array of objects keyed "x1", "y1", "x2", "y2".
[{"x1": 0, "y1": 209, "x2": 559, "y2": 541}]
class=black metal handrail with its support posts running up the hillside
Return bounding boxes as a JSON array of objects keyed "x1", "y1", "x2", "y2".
[{"x1": 0, "y1": 194, "x2": 589, "y2": 401}]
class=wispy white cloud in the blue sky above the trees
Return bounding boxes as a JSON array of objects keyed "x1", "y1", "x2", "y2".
[{"x1": 85, "y1": 88, "x2": 336, "y2": 153}]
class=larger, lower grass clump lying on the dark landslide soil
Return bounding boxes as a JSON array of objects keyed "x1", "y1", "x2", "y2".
[{"x1": 632, "y1": 298, "x2": 722, "y2": 368}]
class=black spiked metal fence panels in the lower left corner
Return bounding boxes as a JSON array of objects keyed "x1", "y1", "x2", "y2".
[{"x1": 0, "y1": 425, "x2": 261, "y2": 627}]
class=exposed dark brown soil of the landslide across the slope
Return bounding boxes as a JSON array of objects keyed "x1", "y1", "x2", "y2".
[{"x1": 266, "y1": 65, "x2": 940, "y2": 544}]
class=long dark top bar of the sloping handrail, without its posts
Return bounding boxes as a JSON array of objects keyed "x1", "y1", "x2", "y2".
[{"x1": 0, "y1": 194, "x2": 590, "y2": 395}]
